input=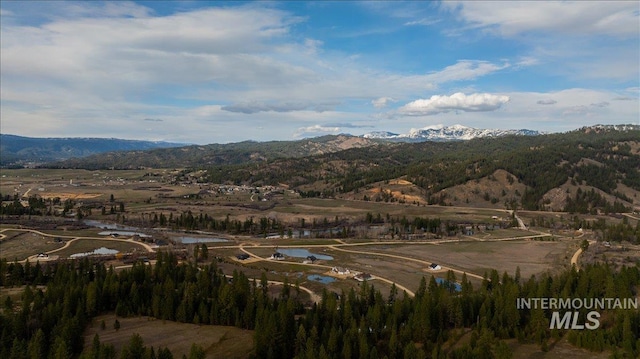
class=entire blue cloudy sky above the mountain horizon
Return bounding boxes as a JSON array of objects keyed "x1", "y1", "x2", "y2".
[{"x1": 0, "y1": 0, "x2": 640, "y2": 144}]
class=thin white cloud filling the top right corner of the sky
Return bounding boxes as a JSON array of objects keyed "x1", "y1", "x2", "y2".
[{"x1": 440, "y1": 1, "x2": 640, "y2": 87}]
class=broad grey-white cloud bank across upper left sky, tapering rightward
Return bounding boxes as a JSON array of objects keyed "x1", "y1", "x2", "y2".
[{"x1": 0, "y1": 3, "x2": 508, "y2": 119}]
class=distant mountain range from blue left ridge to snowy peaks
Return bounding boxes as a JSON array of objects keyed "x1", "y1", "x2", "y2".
[{"x1": 0, "y1": 125, "x2": 540, "y2": 167}]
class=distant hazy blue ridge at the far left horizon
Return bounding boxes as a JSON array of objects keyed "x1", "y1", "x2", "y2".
[{"x1": 0, "y1": 134, "x2": 185, "y2": 166}]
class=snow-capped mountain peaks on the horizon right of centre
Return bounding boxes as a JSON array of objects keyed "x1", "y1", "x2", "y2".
[{"x1": 362, "y1": 125, "x2": 540, "y2": 142}]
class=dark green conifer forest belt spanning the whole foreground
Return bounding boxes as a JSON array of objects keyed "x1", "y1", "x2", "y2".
[{"x1": 0, "y1": 254, "x2": 640, "y2": 358}]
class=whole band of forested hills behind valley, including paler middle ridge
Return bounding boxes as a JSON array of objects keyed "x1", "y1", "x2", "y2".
[{"x1": 45, "y1": 125, "x2": 640, "y2": 213}]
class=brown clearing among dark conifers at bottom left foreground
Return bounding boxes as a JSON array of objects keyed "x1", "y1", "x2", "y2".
[{"x1": 84, "y1": 315, "x2": 253, "y2": 358}]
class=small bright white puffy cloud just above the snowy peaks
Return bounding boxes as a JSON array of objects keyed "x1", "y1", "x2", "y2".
[{"x1": 398, "y1": 92, "x2": 509, "y2": 116}]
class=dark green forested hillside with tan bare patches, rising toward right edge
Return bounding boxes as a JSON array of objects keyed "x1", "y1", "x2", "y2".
[{"x1": 202, "y1": 126, "x2": 640, "y2": 212}]
